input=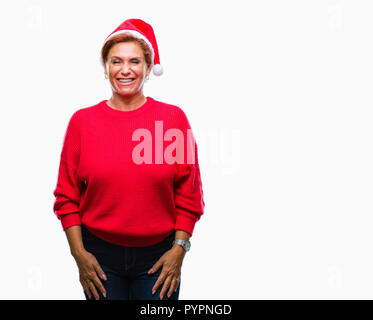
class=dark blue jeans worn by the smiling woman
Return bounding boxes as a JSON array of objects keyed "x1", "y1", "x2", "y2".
[{"x1": 81, "y1": 225, "x2": 181, "y2": 300}]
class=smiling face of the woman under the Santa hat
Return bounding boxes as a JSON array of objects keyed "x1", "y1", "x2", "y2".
[{"x1": 105, "y1": 42, "x2": 150, "y2": 97}]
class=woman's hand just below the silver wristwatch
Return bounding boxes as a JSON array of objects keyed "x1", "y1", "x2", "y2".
[{"x1": 148, "y1": 244, "x2": 185, "y2": 300}]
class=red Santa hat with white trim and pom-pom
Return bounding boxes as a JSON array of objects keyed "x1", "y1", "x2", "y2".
[{"x1": 100, "y1": 19, "x2": 163, "y2": 76}]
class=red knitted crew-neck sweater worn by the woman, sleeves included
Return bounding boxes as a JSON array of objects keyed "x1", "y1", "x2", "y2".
[{"x1": 53, "y1": 97, "x2": 205, "y2": 247}]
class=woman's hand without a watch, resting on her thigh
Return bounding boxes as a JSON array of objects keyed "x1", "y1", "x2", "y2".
[{"x1": 74, "y1": 250, "x2": 107, "y2": 300}]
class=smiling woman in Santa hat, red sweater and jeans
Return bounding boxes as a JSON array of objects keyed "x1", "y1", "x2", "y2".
[{"x1": 53, "y1": 19, "x2": 205, "y2": 300}]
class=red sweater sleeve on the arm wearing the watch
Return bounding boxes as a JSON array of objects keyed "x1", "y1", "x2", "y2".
[{"x1": 174, "y1": 112, "x2": 205, "y2": 235}]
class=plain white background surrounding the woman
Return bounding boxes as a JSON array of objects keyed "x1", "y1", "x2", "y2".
[{"x1": 0, "y1": 0, "x2": 373, "y2": 300}]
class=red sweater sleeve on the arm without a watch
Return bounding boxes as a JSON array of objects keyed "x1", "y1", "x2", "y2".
[{"x1": 53, "y1": 112, "x2": 81, "y2": 230}]
